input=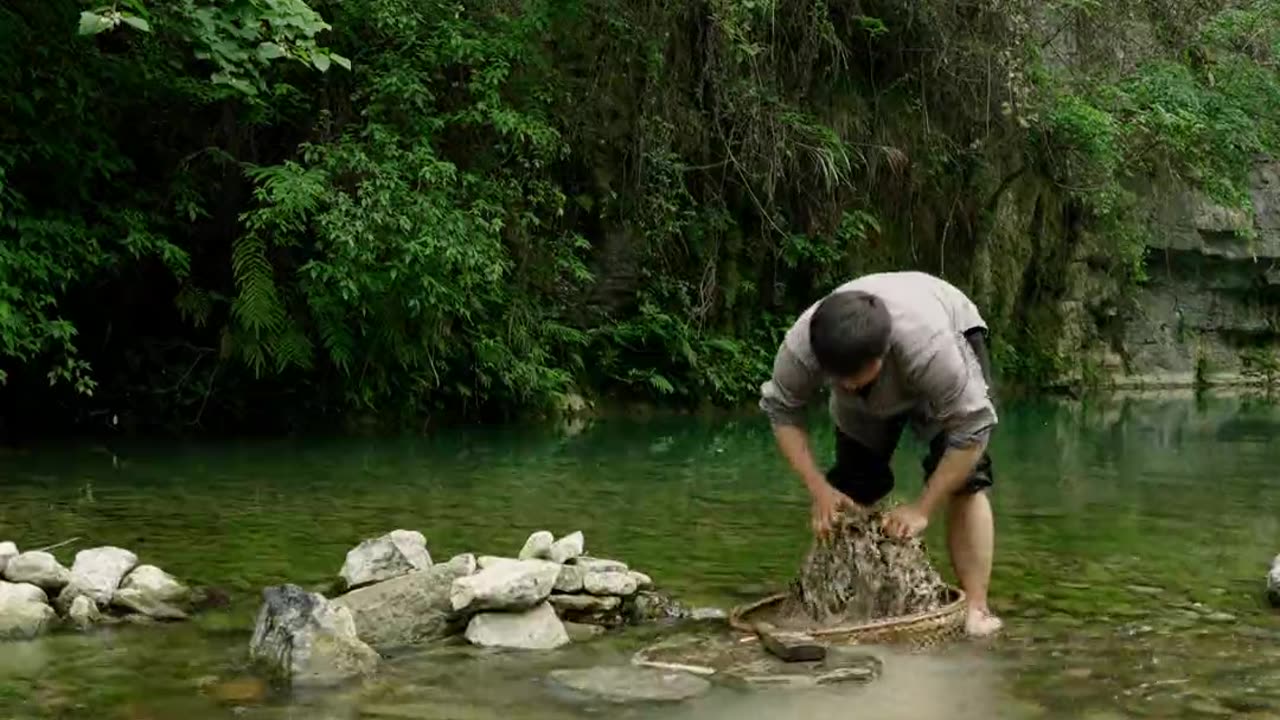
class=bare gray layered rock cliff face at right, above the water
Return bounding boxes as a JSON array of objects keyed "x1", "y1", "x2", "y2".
[{"x1": 1095, "y1": 159, "x2": 1280, "y2": 387}]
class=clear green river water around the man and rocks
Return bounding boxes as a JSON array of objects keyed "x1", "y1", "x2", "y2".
[{"x1": 0, "y1": 397, "x2": 1280, "y2": 720}]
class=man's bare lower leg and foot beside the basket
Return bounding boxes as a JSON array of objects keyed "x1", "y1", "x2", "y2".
[{"x1": 947, "y1": 492, "x2": 1004, "y2": 637}]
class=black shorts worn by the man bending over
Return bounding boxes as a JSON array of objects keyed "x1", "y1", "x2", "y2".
[{"x1": 827, "y1": 325, "x2": 995, "y2": 505}]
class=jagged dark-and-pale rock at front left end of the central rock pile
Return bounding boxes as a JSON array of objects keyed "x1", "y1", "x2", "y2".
[{"x1": 250, "y1": 585, "x2": 379, "y2": 685}]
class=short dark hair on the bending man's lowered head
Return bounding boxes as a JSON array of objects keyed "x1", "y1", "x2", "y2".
[{"x1": 809, "y1": 291, "x2": 890, "y2": 377}]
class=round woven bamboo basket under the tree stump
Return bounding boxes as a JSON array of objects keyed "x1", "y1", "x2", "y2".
[{"x1": 728, "y1": 585, "x2": 966, "y2": 650}]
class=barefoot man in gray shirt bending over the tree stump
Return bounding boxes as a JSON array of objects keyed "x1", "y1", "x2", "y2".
[{"x1": 760, "y1": 272, "x2": 1001, "y2": 635}]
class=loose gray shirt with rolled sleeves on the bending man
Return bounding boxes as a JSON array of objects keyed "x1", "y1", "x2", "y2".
[{"x1": 760, "y1": 272, "x2": 997, "y2": 452}]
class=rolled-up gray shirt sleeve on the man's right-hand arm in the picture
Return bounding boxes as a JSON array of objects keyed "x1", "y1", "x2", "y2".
[{"x1": 914, "y1": 340, "x2": 998, "y2": 447}]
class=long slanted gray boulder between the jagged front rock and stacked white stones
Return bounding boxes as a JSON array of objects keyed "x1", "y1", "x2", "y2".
[{"x1": 333, "y1": 555, "x2": 475, "y2": 652}]
